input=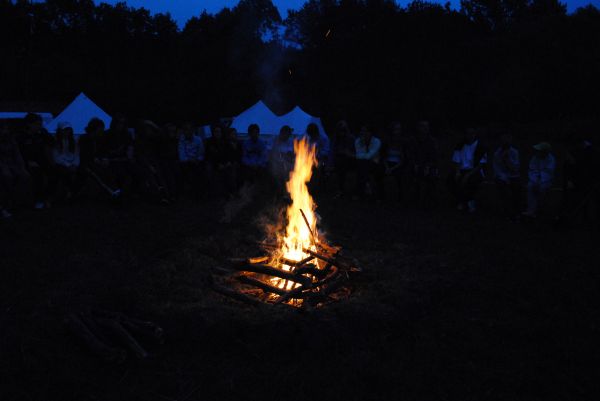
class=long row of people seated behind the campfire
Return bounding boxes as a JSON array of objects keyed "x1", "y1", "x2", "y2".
[{"x1": 0, "y1": 113, "x2": 599, "y2": 225}]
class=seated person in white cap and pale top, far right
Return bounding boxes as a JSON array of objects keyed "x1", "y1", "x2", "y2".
[{"x1": 523, "y1": 142, "x2": 556, "y2": 218}]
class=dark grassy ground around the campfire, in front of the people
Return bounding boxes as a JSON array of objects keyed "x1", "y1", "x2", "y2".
[{"x1": 0, "y1": 185, "x2": 600, "y2": 401}]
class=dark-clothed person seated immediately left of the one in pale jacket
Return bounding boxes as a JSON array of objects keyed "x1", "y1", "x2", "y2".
[{"x1": 332, "y1": 120, "x2": 356, "y2": 196}]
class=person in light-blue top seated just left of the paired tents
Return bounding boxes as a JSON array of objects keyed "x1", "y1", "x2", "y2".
[{"x1": 178, "y1": 122, "x2": 208, "y2": 197}]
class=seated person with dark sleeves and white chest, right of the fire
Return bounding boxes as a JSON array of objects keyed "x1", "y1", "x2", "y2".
[{"x1": 448, "y1": 128, "x2": 487, "y2": 213}]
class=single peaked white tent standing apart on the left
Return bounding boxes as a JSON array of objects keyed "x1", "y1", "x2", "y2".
[{"x1": 46, "y1": 92, "x2": 112, "y2": 135}]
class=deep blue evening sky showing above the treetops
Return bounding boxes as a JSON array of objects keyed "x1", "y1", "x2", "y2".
[{"x1": 96, "y1": 0, "x2": 600, "y2": 26}]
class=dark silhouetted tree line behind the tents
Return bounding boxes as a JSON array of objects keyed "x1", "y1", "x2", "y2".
[{"x1": 0, "y1": 0, "x2": 600, "y2": 128}]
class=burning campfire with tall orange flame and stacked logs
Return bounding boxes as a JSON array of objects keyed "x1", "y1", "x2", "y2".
[{"x1": 221, "y1": 139, "x2": 360, "y2": 307}]
